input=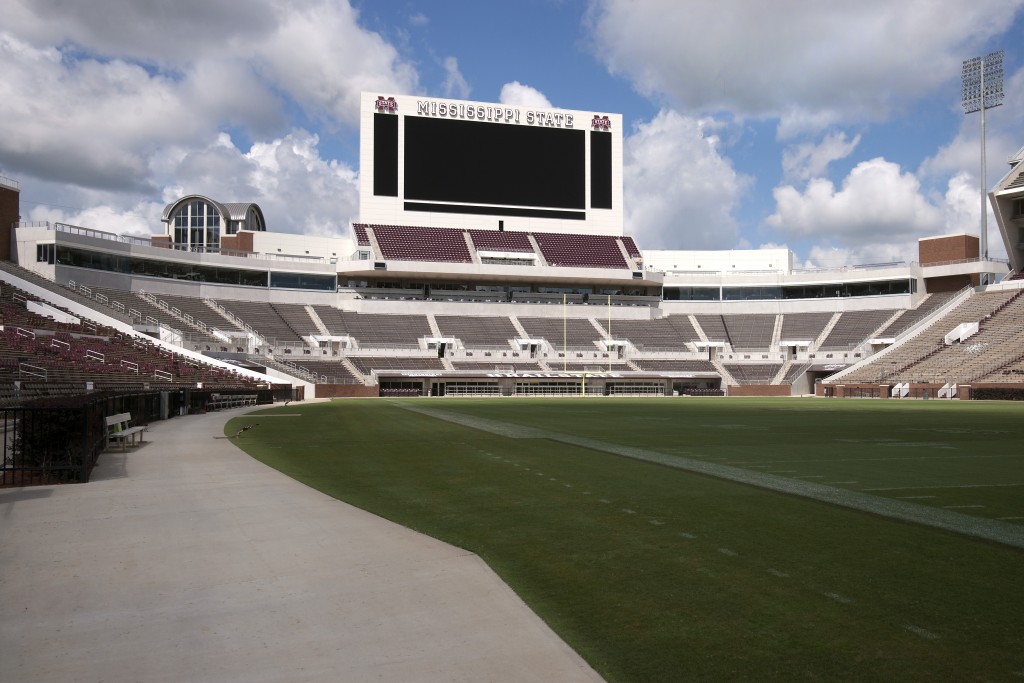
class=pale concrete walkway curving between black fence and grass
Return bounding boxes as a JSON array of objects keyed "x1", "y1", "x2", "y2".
[{"x1": 0, "y1": 409, "x2": 600, "y2": 683}]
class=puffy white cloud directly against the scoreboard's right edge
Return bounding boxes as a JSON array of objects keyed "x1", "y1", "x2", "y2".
[{"x1": 623, "y1": 110, "x2": 750, "y2": 249}]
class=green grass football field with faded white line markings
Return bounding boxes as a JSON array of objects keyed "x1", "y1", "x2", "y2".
[{"x1": 225, "y1": 398, "x2": 1024, "y2": 681}]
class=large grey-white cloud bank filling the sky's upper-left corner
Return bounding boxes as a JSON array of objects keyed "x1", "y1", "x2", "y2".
[{"x1": 0, "y1": 0, "x2": 418, "y2": 191}]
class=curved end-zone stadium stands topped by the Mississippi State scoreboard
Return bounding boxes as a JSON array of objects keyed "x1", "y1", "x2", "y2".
[{"x1": 0, "y1": 92, "x2": 1024, "y2": 396}]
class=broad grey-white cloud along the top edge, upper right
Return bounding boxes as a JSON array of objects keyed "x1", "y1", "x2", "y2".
[{"x1": 588, "y1": 0, "x2": 1022, "y2": 135}]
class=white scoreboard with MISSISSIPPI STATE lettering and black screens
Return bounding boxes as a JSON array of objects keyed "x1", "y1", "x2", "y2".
[{"x1": 359, "y1": 92, "x2": 623, "y2": 234}]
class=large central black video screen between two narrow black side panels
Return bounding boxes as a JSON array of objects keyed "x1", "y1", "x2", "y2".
[{"x1": 404, "y1": 116, "x2": 587, "y2": 210}]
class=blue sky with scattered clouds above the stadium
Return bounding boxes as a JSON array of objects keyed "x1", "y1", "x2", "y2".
[{"x1": 0, "y1": 0, "x2": 1024, "y2": 267}]
